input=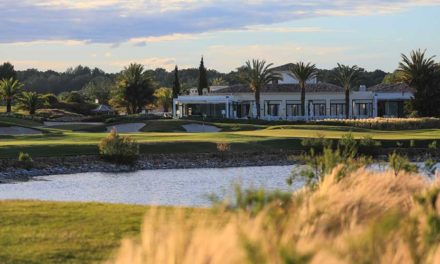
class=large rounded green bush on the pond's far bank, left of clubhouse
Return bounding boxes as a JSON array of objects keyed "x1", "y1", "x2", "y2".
[{"x1": 99, "y1": 129, "x2": 139, "y2": 165}]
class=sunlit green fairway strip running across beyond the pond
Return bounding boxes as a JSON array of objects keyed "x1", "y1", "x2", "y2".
[{"x1": 0, "y1": 125, "x2": 440, "y2": 158}]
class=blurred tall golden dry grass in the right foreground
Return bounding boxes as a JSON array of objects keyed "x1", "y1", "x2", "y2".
[{"x1": 110, "y1": 168, "x2": 440, "y2": 264}]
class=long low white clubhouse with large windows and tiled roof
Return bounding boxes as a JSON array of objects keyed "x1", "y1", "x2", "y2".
[{"x1": 173, "y1": 65, "x2": 413, "y2": 120}]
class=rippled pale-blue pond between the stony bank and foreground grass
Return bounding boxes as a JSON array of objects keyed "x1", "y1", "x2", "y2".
[{"x1": 0, "y1": 166, "x2": 302, "y2": 207}]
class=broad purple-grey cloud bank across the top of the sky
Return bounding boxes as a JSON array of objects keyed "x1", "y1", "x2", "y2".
[{"x1": 0, "y1": 0, "x2": 440, "y2": 44}]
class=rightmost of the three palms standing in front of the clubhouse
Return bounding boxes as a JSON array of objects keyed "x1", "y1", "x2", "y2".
[{"x1": 335, "y1": 63, "x2": 360, "y2": 119}]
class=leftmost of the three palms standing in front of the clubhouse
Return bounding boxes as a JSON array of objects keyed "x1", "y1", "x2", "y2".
[{"x1": 239, "y1": 60, "x2": 281, "y2": 119}]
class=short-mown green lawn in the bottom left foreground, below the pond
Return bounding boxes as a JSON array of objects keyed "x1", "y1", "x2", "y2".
[{"x1": 0, "y1": 201, "x2": 204, "y2": 264}]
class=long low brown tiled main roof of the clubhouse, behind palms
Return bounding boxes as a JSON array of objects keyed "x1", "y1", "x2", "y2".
[{"x1": 212, "y1": 83, "x2": 344, "y2": 94}]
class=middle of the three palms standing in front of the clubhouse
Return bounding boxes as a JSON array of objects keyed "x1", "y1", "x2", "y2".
[{"x1": 290, "y1": 62, "x2": 317, "y2": 116}]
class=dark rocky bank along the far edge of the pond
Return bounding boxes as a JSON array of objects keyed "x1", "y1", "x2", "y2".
[{"x1": 0, "y1": 153, "x2": 294, "y2": 183}]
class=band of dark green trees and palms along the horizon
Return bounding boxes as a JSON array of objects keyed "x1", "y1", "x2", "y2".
[{"x1": 0, "y1": 50, "x2": 440, "y2": 118}]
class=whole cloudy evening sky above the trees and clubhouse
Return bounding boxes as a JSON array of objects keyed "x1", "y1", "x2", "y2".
[{"x1": 0, "y1": 0, "x2": 440, "y2": 72}]
